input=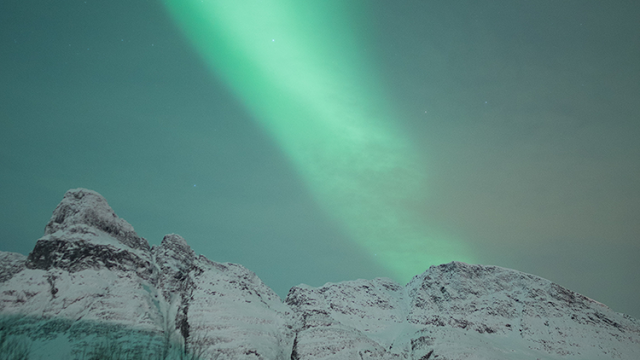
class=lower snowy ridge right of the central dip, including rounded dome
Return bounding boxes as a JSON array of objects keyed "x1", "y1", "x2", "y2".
[{"x1": 286, "y1": 262, "x2": 640, "y2": 359}]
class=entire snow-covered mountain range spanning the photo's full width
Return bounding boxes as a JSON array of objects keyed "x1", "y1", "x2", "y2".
[{"x1": 0, "y1": 189, "x2": 640, "y2": 360}]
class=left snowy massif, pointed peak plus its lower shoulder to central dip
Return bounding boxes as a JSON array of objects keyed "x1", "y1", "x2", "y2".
[{"x1": 0, "y1": 189, "x2": 293, "y2": 360}]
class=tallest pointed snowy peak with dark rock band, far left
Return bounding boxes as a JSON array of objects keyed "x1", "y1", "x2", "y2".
[{"x1": 0, "y1": 189, "x2": 164, "y2": 359}]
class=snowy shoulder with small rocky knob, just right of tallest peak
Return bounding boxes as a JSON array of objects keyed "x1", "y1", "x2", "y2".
[{"x1": 152, "y1": 234, "x2": 293, "y2": 359}]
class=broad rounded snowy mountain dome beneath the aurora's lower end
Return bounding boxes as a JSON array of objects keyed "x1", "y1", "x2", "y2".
[{"x1": 406, "y1": 262, "x2": 640, "y2": 359}]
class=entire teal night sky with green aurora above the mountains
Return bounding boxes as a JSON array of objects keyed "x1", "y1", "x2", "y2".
[{"x1": 0, "y1": 0, "x2": 640, "y2": 318}]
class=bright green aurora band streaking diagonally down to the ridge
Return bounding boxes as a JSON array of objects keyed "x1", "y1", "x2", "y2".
[{"x1": 164, "y1": 0, "x2": 472, "y2": 281}]
